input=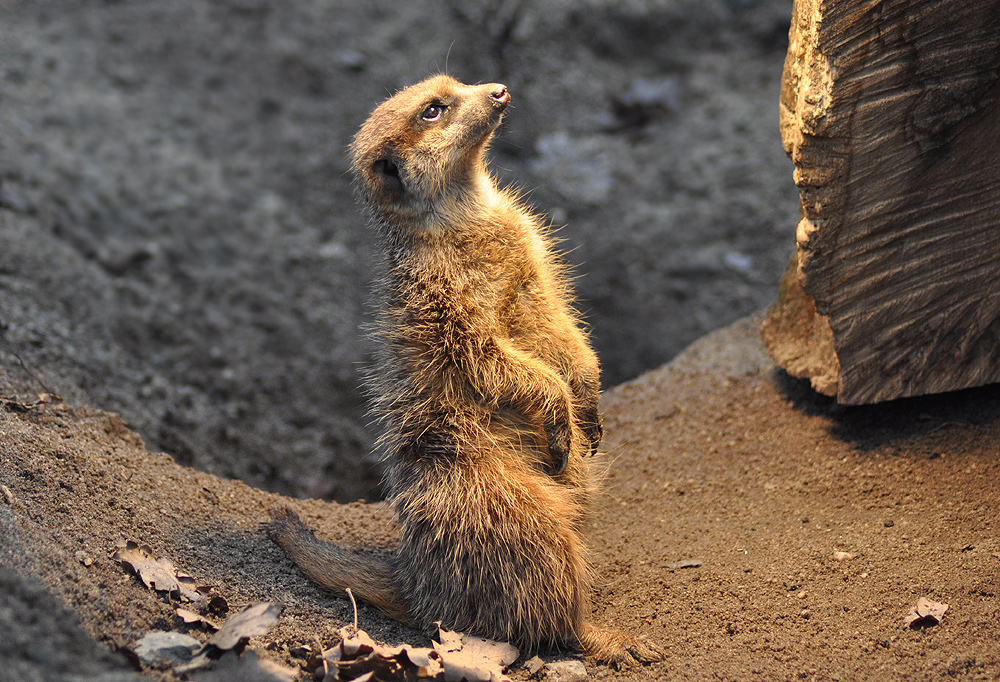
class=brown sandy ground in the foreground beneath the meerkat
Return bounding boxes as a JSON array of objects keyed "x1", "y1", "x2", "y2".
[{"x1": 0, "y1": 319, "x2": 1000, "y2": 680}]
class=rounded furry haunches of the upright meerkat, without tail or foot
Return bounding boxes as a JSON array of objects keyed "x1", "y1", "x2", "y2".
[{"x1": 396, "y1": 460, "x2": 587, "y2": 647}]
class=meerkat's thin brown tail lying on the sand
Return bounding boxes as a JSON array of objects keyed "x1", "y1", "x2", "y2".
[{"x1": 270, "y1": 507, "x2": 411, "y2": 623}]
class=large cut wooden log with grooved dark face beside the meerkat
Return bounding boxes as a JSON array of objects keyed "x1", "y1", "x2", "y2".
[{"x1": 762, "y1": 0, "x2": 1000, "y2": 404}]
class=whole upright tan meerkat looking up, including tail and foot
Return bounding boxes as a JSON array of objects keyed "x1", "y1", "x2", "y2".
[{"x1": 271, "y1": 76, "x2": 662, "y2": 663}]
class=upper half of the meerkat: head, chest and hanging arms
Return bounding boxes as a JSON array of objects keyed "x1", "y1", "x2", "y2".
[{"x1": 353, "y1": 76, "x2": 599, "y2": 494}]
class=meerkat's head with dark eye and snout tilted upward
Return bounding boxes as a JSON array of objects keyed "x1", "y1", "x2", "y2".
[{"x1": 351, "y1": 76, "x2": 510, "y2": 222}]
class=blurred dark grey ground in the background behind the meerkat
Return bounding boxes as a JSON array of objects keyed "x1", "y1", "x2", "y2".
[{"x1": 0, "y1": 0, "x2": 797, "y2": 501}]
